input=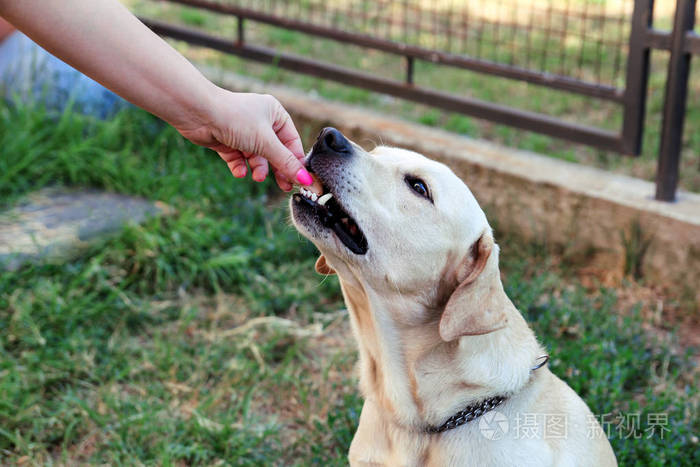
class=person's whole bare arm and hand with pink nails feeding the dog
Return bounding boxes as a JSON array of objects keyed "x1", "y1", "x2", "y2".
[{"x1": 0, "y1": 0, "x2": 312, "y2": 191}]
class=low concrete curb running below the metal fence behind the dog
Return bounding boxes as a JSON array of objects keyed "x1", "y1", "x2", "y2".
[{"x1": 200, "y1": 66, "x2": 700, "y2": 303}]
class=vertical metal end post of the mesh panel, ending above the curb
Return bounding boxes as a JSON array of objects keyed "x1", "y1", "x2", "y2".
[{"x1": 622, "y1": 0, "x2": 654, "y2": 155}]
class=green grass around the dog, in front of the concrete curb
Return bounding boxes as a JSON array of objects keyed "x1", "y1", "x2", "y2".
[{"x1": 0, "y1": 102, "x2": 700, "y2": 466}]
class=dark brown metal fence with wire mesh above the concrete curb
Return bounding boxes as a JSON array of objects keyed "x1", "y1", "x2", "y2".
[{"x1": 142, "y1": 0, "x2": 700, "y2": 201}]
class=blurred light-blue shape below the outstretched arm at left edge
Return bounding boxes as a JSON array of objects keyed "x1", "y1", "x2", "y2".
[{"x1": 0, "y1": 31, "x2": 127, "y2": 118}]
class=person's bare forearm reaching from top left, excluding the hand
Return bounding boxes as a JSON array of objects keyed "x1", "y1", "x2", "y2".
[{"x1": 0, "y1": 0, "x2": 214, "y2": 128}]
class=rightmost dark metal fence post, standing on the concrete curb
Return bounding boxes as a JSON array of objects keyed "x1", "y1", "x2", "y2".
[{"x1": 656, "y1": 0, "x2": 696, "y2": 201}]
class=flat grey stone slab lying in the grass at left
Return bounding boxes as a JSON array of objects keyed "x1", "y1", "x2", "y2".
[{"x1": 0, "y1": 188, "x2": 169, "y2": 270}]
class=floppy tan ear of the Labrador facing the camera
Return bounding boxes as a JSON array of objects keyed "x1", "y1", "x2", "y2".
[{"x1": 440, "y1": 232, "x2": 508, "y2": 342}]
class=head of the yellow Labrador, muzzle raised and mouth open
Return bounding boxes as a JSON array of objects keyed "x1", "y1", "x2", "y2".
[{"x1": 290, "y1": 128, "x2": 505, "y2": 341}]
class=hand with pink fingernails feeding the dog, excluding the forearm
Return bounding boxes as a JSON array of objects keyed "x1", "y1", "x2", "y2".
[{"x1": 174, "y1": 87, "x2": 313, "y2": 191}]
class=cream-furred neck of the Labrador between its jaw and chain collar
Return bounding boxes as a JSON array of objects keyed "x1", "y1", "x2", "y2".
[{"x1": 339, "y1": 272, "x2": 544, "y2": 431}]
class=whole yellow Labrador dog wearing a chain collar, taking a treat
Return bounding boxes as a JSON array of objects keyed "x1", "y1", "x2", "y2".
[{"x1": 290, "y1": 128, "x2": 617, "y2": 467}]
